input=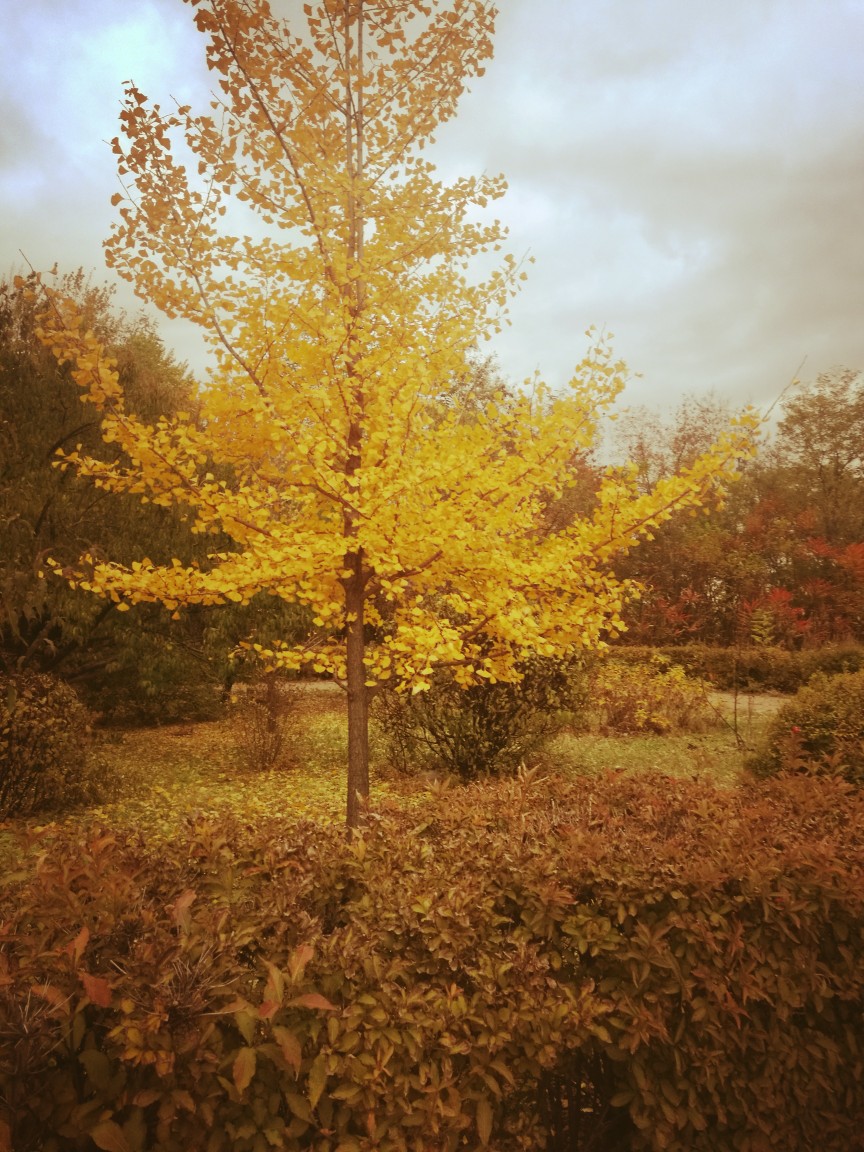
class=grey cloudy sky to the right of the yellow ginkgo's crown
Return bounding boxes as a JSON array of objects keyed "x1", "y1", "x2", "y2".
[{"x1": 453, "y1": 0, "x2": 864, "y2": 401}]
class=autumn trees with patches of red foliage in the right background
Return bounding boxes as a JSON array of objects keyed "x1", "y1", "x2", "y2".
[{"x1": 617, "y1": 367, "x2": 864, "y2": 649}]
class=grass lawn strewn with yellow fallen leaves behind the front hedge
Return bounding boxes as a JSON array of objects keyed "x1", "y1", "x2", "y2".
[{"x1": 6, "y1": 684, "x2": 782, "y2": 838}]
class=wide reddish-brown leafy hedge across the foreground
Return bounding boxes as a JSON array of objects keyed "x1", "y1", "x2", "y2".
[{"x1": 0, "y1": 775, "x2": 864, "y2": 1152}]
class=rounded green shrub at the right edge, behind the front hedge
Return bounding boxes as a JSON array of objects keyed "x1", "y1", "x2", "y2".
[{"x1": 748, "y1": 672, "x2": 864, "y2": 785}]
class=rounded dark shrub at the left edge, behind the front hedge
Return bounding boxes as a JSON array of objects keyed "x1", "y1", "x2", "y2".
[{"x1": 0, "y1": 673, "x2": 99, "y2": 817}]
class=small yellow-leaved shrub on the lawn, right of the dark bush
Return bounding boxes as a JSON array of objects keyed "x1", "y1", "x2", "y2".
[{"x1": 591, "y1": 655, "x2": 715, "y2": 733}]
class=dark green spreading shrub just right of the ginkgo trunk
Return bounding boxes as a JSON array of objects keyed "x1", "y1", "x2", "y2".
[{"x1": 373, "y1": 659, "x2": 585, "y2": 780}]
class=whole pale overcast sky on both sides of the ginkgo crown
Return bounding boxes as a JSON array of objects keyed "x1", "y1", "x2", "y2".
[{"x1": 0, "y1": 0, "x2": 864, "y2": 407}]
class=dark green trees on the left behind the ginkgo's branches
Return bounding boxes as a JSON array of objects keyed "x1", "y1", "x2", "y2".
[{"x1": 0, "y1": 270, "x2": 303, "y2": 721}]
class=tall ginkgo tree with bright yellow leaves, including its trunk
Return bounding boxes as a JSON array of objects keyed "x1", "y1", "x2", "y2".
[{"x1": 32, "y1": 0, "x2": 749, "y2": 826}]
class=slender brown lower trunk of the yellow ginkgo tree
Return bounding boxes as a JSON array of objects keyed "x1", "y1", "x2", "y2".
[{"x1": 344, "y1": 553, "x2": 369, "y2": 829}]
